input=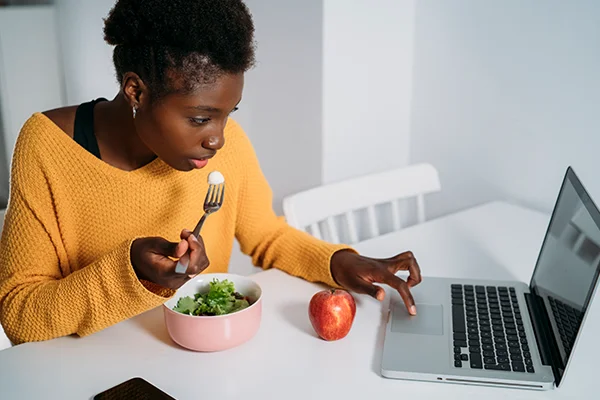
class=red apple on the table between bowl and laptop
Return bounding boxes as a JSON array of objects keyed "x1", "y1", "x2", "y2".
[{"x1": 308, "y1": 289, "x2": 356, "y2": 341}]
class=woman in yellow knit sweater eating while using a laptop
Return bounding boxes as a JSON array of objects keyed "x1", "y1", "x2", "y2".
[{"x1": 0, "y1": 0, "x2": 421, "y2": 344}]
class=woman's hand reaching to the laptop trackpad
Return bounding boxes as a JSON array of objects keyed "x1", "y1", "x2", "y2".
[{"x1": 331, "y1": 250, "x2": 421, "y2": 315}]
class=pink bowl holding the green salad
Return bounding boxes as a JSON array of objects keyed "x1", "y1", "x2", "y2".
[{"x1": 163, "y1": 274, "x2": 262, "y2": 351}]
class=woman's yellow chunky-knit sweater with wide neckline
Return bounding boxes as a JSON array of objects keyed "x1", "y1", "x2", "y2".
[{"x1": 0, "y1": 113, "x2": 346, "y2": 344}]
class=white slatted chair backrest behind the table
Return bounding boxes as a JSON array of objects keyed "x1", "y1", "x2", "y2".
[{"x1": 283, "y1": 163, "x2": 441, "y2": 244}]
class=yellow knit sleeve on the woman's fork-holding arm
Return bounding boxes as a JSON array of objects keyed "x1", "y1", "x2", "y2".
[{"x1": 0, "y1": 138, "x2": 173, "y2": 344}]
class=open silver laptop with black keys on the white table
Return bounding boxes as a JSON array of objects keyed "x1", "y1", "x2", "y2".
[{"x1": 381, "y1": 167, "x2": 600, "y2": 390}]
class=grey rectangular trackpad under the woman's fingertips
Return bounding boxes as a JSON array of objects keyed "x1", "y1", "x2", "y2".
[{"x1": 392, "y1": 302, "x2": 444, "y2": 335}]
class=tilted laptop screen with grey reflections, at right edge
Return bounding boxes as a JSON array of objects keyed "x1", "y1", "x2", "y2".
[{"x1": 531, "y1": 168, "x2": 600, "y2": 372}]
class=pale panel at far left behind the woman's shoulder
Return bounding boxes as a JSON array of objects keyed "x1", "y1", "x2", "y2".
[{"x1": 0, "y1": 6, "x2": 64, "y2": 207}]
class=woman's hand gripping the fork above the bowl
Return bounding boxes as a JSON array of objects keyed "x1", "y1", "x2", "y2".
[{"x1": 131, "y1": 229, "x2": 209, "y2": 289}]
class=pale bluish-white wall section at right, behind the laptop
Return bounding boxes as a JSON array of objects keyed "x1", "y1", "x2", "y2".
[{"x1": 410, "y1": 0, "x2": 600, "y2": 219}]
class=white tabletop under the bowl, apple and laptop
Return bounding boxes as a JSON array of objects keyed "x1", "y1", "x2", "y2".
[{"x1": 0, "y1": 203, "x2": 600, "y2": 400}]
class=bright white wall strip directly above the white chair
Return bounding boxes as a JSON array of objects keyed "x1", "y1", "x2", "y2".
[{"x1": 322, "y1": 0, "x2": 417, "y2": 183}]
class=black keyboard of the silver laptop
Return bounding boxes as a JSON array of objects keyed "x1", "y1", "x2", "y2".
[{"x1": 451, "y1": 284, "x2": 535, "y2": 373}]
